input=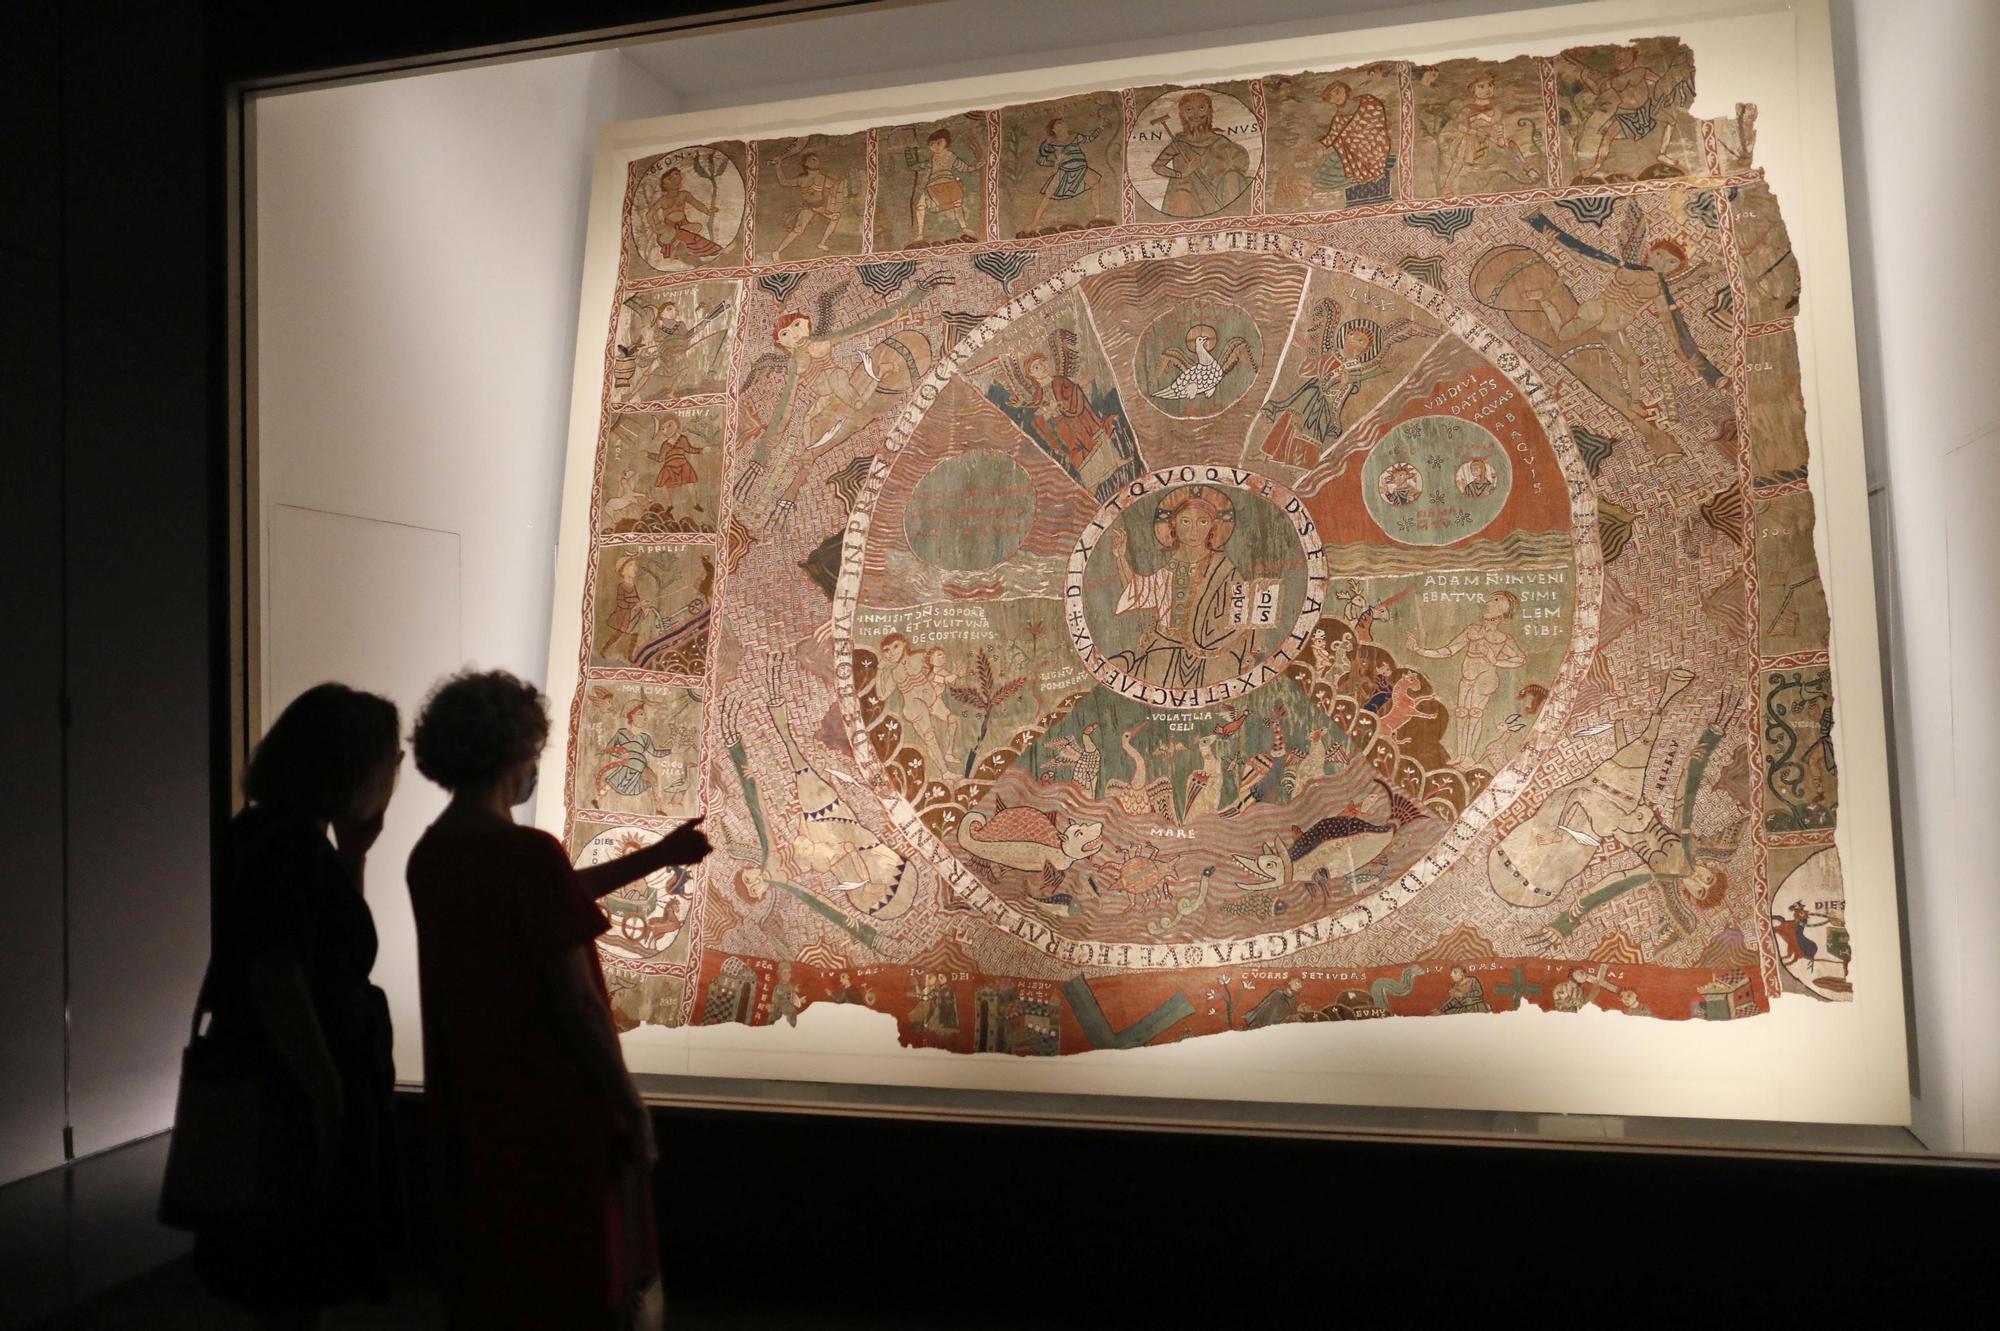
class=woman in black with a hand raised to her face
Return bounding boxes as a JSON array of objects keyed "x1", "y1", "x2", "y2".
[{"x1": 194, "y1": 683, "x2": 402, "y2": 1327}]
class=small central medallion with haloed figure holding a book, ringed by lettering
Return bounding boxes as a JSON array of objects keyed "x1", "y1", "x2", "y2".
[{"x1": 1062, "y1": 466, "x2": 1326, "y2": 707}]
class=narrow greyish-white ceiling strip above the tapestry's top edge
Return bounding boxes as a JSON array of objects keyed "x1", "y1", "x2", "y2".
[{"x1": 622, "y1": 0, "x2": 1550, "y2": 110}]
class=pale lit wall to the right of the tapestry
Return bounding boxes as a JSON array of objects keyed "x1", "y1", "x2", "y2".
[{"x1": 1834, "y1": 0, "x2": 2000, "y2": 1151}]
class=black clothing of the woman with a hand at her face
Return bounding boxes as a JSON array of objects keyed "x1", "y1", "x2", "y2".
[{"x1": 196, "y1": 805, "x2": 398, "y2": 1307}]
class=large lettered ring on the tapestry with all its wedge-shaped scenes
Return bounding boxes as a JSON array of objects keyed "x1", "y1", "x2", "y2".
[{"x1": 834, "y1": 232, "x2": 1602, "y2": 969}]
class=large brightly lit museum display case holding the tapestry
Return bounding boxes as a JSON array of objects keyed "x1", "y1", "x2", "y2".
[{"x1": 238, "y1": 0, "x2": 2000, "y2": 1159}]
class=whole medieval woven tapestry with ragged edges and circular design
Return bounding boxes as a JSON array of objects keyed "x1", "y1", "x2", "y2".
[{"x1": 558, "y1": 38, "x2": 1854, "y2": 1055}]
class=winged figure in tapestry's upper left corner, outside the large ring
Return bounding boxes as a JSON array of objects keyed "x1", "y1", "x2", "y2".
[{"x1": 736, "y1": 274, "x2": 952, "y2": 512}]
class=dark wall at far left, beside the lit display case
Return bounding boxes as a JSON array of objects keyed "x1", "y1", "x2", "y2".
[{"x1": 0, "y1": 0, "x2": 210, "y2": 1191}]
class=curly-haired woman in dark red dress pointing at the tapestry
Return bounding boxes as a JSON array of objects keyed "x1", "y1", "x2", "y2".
[{"x1": 410, "y1": 669, "x2": 708, "y2": 1329}]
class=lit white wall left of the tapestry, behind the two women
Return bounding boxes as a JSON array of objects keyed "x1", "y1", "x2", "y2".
[{"x1": 256, "y1": 52, "x2": 674, "y2": 1077}]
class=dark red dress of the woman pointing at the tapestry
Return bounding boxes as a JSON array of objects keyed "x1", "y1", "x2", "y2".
[{"x1": 410, "y1": 825, "x2": 658, "y2": 1329}]
